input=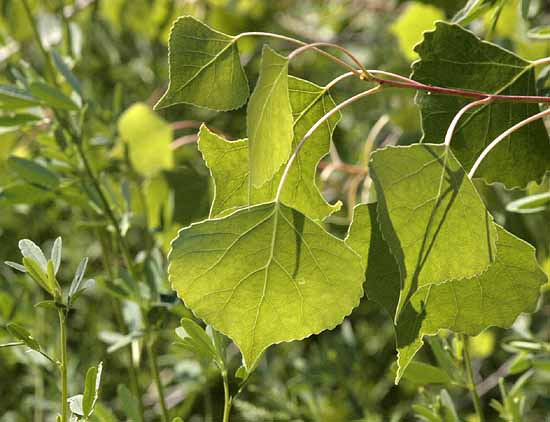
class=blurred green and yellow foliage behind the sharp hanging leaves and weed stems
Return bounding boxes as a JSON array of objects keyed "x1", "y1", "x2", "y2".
[{"x1": 0, "y1": 0, "x2": 550, "y2": 421}]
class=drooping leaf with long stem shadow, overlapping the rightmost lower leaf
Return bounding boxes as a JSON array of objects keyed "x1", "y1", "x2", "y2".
[{"x1": 370, "y1": 144, "x2": 496, "y2": 320}]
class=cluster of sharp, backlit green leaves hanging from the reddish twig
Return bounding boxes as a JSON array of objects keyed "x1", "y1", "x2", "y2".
[{"x1": 159, "y1": 17, "x2": 550, "y2": 380}]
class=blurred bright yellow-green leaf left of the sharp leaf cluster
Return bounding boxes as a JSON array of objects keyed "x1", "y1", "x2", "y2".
[{"x1": 118, "y1": 103, "x2": 174, "y2": 177}]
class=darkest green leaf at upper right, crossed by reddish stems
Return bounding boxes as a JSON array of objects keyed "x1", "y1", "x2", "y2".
[{"x1": 412, "y1": 22, "x2": 550, "y2": 188}]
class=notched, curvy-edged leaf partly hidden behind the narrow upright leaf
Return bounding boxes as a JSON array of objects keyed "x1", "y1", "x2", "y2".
[{"x1": 198, "y1": 76, "x2": 341, "y2": 221}]
